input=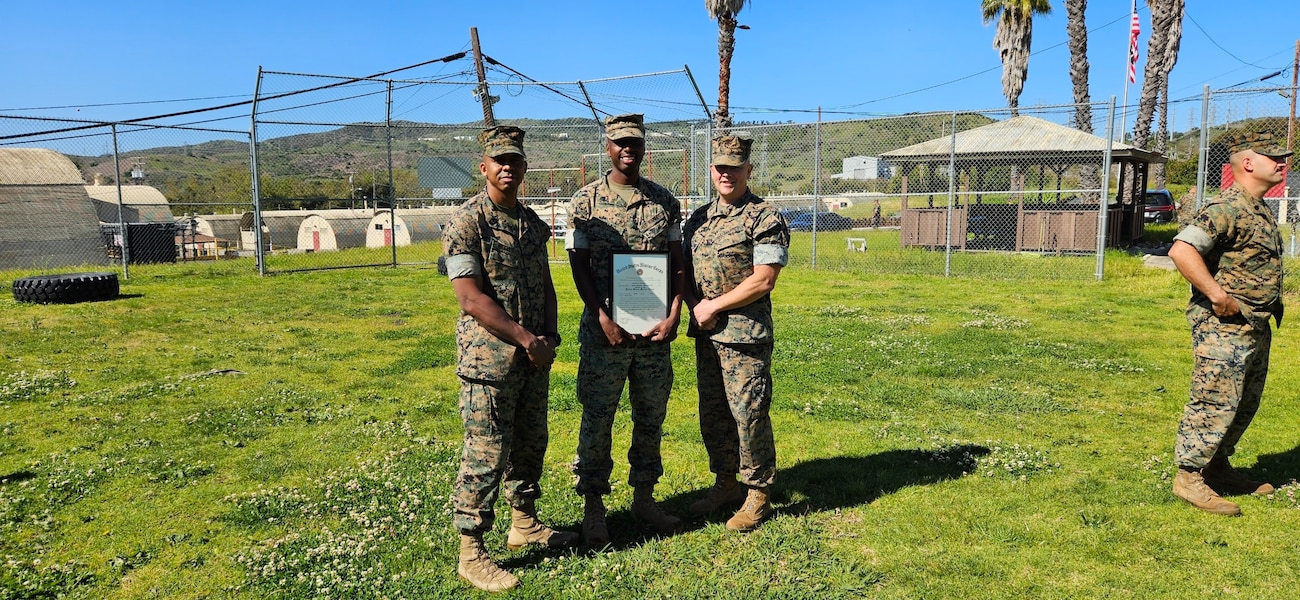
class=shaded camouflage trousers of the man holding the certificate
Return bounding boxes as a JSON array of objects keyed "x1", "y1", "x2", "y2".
[{"x1": 573, "y1": 340, "x2": 672, "y2": 496}]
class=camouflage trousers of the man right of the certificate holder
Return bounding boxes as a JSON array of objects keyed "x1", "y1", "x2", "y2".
[{"x1": 696, "y1": 338, "x2": 776, "y2": 488}]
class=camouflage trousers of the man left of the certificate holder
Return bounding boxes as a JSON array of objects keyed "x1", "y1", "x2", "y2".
[{"x1": 451, "y1": 368, "x2": 550, "y2": 532}]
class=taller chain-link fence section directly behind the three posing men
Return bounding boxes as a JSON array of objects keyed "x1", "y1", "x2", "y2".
[{"x1": 246, "y1": 64, "x2": 705, "y2": 271}]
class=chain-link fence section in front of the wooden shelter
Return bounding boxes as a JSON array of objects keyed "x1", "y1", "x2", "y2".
[{"x1": 697, "y1": 105, "x2": 1128, "y2": 279}]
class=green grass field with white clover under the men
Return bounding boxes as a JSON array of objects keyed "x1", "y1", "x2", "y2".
[{"x1": 0, "y1": 256, "x2": 1300, "y2": 599}]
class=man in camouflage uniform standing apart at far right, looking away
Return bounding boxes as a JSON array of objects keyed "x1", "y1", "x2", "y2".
[{"x1": 1169, "y1": 134, "x2": 1290, "y2": 514}]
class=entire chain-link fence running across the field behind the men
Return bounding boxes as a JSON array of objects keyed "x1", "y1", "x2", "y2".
[{"x1": 0, "y1": 78, "x2": 1300, "y2": 279}]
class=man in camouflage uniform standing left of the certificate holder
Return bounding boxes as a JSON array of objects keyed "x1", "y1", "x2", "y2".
[{"x1": 442, "y1": 126, "x2": 576, "y2": 591}]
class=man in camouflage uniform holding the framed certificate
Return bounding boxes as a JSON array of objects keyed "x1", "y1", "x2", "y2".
[{"x1": 564, "y1": 114, "x2": 683, "y2": 545}]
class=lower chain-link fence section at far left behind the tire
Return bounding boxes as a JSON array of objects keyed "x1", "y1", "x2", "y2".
[{"x1": 0, "y1": 116, "x2": 251, "y2": 274}]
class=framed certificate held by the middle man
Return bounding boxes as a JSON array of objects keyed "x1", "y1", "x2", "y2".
[{"x1": 610, "y1": 252, "x2": 672, "y2": 335}]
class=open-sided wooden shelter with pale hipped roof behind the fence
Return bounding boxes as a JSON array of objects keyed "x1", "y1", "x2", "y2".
[{"x1": 880, "y1": 116, "x2": 1165, "y2": 252}]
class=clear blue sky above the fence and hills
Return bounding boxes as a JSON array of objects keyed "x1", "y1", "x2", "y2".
[{"x1": 0, "y1": 0, "x2": 1300, "y2": 130}]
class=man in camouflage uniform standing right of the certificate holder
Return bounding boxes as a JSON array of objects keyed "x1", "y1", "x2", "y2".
[{"x1": 683, "y1": 135, "x2": 790, "y2": 531}]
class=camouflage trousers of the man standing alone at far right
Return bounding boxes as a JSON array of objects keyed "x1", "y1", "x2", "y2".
[{"x1": 1174, "y1": 304, "x2": 1273, "y2": 469}]
